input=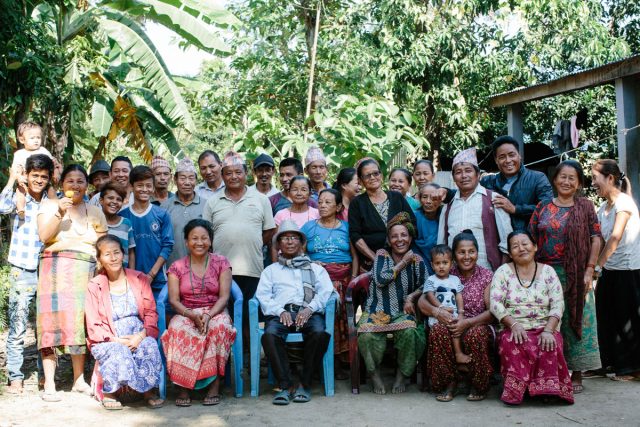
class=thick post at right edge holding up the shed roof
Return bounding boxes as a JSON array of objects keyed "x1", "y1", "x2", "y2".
[{"x1": 616, "y1": 75, "x2": 640, "y2": 204}]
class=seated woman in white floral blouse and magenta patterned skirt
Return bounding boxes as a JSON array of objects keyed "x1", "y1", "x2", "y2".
[{"x1": 490, "y1": 230, "x2": 573, "y2": 405}]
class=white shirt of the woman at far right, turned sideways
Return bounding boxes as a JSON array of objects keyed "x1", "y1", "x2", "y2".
[{"x1": 598, "y1": 193, "x2": 640, "y2": 270}]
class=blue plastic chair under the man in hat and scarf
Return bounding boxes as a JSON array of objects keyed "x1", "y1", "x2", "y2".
[{"x1": 249, "y1": 292, "x2": 336, "y2": 397}]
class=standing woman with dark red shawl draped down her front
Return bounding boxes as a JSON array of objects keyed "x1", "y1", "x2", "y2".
[{"x1": 529, "y1": 160, "x2": 601, "y2": 393}]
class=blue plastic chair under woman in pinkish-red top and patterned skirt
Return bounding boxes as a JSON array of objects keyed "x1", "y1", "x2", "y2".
[{"x1": 156, "y1": 281, "x2": 244, "y2": 400}]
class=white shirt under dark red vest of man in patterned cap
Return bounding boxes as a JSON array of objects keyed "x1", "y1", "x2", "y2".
[{"x1": 438, "y1": 184, "x2": 513, "y2": 270}]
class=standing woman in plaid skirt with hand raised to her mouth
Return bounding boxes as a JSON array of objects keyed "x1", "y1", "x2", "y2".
[{"x1": 37, "y1": 165, "x2": 107, "y2": 401}]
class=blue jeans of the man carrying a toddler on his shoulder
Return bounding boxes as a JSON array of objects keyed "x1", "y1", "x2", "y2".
[{"x1": 7, "y1": 267, "x2": 38, "y2": 381}]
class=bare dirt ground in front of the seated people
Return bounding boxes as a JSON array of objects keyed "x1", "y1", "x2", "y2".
[{"x1": 0, "y1": 333, "x2": 640, "y2": 427}]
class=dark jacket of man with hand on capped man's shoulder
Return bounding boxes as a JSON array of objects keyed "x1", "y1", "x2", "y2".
[{"x1": 480, "y1": 166, "x2": 553, "y2": 230}]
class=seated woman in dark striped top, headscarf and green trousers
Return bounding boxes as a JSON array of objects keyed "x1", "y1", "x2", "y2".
[{"x1": 358, "y1": 212, "x2": 427, "y2": 394}]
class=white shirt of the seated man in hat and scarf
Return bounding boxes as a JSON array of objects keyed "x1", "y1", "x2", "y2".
[{"x1": 256, "y1": 262, "x2": 333, "y2": 316}]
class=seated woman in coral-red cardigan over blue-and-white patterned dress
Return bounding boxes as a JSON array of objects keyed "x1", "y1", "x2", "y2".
[{"x1": 85, "y1": 235, "x2": 164, "y2": 410}]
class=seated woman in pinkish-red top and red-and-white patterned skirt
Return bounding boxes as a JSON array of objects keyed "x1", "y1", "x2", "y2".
[{"x1": 161, "y1": 219, "x2": 236, "y2": 406}]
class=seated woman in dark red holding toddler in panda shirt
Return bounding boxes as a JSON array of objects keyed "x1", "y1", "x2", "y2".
[{"x1": 418, "y1": 230, "x2": 493, "y2": 402}]
